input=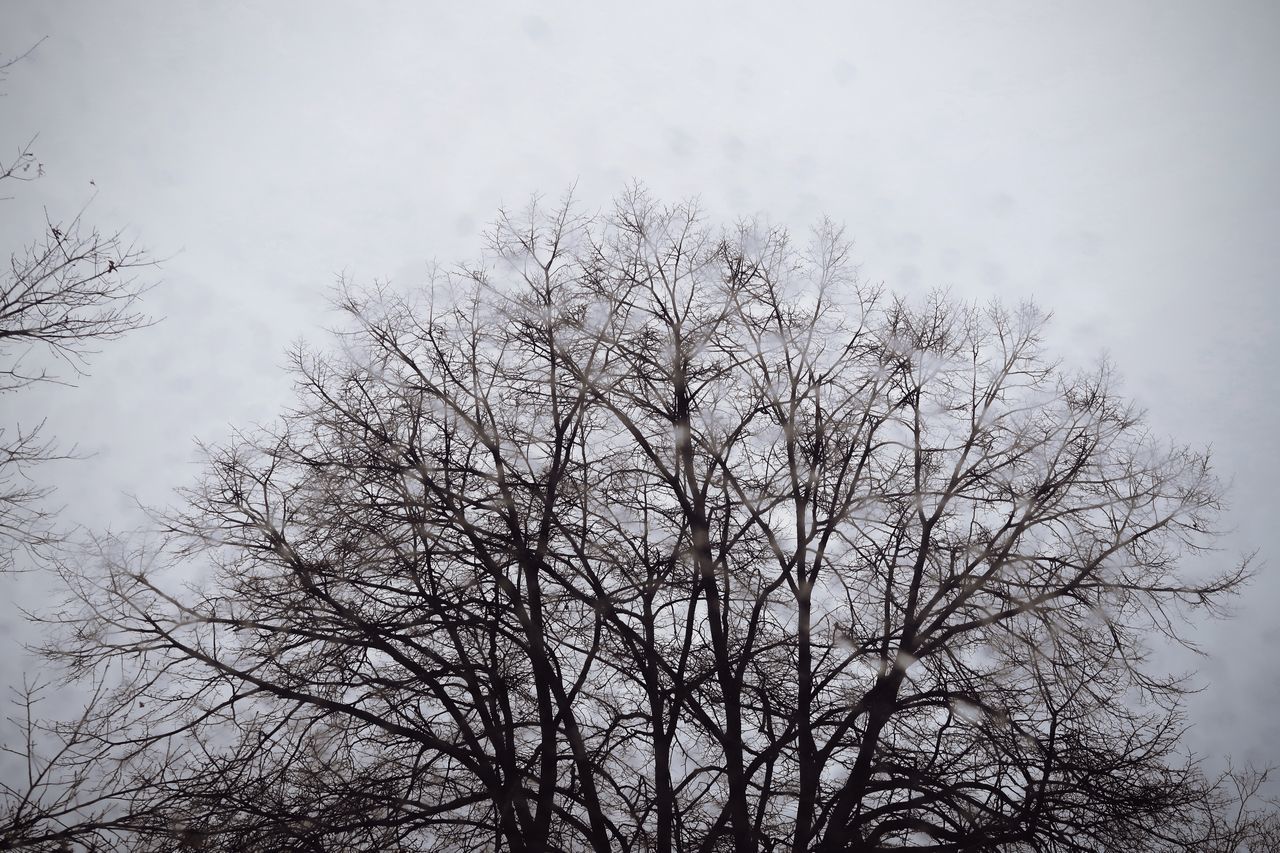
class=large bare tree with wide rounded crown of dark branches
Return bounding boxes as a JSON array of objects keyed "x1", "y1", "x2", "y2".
[{"x1": 20, "y1": 192, "x2": 1247, "y2": 853}]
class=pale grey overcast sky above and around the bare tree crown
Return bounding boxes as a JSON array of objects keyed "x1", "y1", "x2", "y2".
[{"x1": 0, "y1": 0, "x2": 1280, "y2": 763}]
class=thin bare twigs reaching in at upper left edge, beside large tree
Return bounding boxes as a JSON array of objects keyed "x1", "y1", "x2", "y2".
[{"x1": 0, "y1": 41, "x2": 148, "y2": 571}]
